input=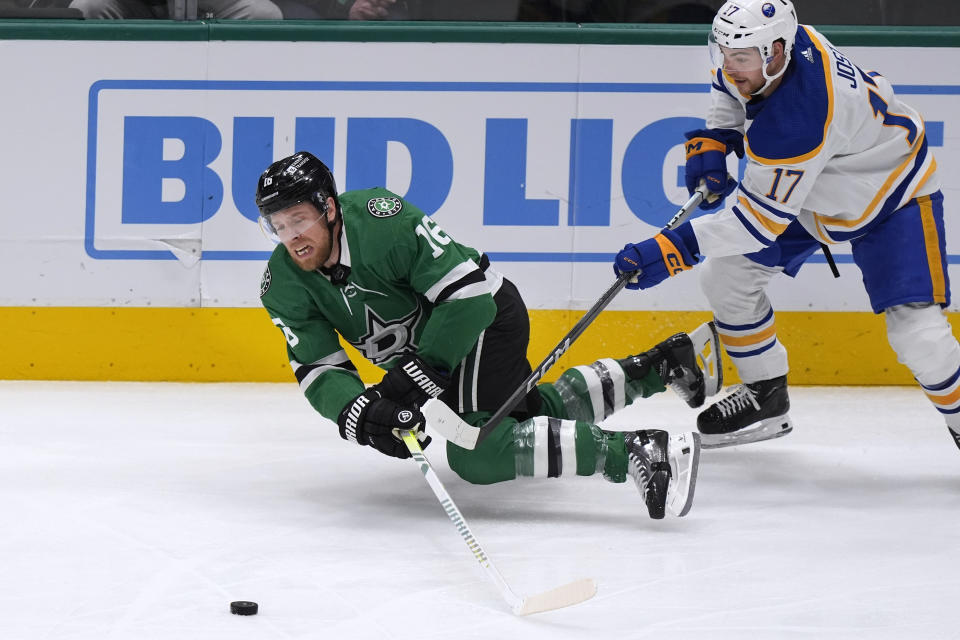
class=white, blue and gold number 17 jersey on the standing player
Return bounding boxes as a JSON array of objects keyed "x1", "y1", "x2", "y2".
[{"x1": 692, "y1": 25, "x2": 940, "y2": 256}]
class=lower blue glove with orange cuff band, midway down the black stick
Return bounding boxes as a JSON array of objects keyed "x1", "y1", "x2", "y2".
[{"x1": 613, "y1": 222, "x2": 700, "y2": 289}]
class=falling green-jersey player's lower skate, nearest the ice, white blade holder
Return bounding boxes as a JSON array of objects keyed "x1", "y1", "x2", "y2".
[{"x1": 624, "y1": 429, "x2": 700, "y2": 520}]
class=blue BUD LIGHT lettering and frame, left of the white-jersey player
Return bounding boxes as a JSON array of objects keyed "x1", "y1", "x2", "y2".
[{"x1": 85, "y1": 80, "x2": 737, "y2": 267}]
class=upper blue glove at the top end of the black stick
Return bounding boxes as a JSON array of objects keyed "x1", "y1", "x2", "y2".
[{"x1": 683, "y1": 129, "x2": 743, "y2": 210}]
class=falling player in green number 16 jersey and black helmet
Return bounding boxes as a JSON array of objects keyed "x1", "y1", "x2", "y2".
[{"x1": 256, "y1": 152, "x2": 719, "y2": 518}]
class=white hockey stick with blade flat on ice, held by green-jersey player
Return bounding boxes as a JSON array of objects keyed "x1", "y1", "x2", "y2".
[{"x1": 400, "y1": 431, "x2": 597, "y2": 616}]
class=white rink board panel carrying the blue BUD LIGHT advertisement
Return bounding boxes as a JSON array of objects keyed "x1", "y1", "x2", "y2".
[{"x1": 0, "y1": 41, "x2": 960, "y2": 311}]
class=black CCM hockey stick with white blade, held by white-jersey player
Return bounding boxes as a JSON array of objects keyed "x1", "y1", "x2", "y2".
[{"x1": 422, "y1": 186, "x2": 706, "y2": 449}]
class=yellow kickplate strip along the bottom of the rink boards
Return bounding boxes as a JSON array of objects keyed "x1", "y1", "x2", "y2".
[{"x1": 0, "y1": 307, "x2": 960, "y2": 385}]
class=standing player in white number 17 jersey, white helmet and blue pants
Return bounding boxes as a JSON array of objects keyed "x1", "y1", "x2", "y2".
[{"x1": 614, "y1": 0, "x2": 960, "y2": 447}]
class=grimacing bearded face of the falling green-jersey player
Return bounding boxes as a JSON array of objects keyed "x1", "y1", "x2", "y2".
[{"x1": 270, "y1": 198, "x2": 336, "y2": 271}]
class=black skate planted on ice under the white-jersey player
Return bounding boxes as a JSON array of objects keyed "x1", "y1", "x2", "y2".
[{"x1": 697, "y1": 376, "x2": 793, "y2": 449}]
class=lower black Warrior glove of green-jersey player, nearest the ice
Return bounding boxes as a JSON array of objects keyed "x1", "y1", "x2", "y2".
[{"x1": 337, "y1": 389, "x2": 432, "y2": 458}]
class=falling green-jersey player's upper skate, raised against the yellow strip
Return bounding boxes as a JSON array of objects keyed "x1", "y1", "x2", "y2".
[{"x1": 618, "y1": 322, "x2": 723, "y2": 407}]
